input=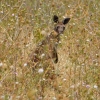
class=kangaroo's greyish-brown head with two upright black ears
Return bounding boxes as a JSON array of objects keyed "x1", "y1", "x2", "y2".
[{"x1": 53, "y1": 15, "x2": 70, "y2": 35}]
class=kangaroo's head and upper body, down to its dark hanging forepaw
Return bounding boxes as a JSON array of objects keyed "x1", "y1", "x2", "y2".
[{"x1": 30, "y1": 15, "x2": 70, "y2": 72}]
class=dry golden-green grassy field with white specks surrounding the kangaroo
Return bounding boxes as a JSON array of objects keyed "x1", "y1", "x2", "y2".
[{"x1": 0, "y1": 0, "x2": 100, "y2": 100}]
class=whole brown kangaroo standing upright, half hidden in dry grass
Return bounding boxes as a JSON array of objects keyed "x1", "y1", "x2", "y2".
[{"x1": 30, "y1": 15, "x2": 70, "y2": 98}]
